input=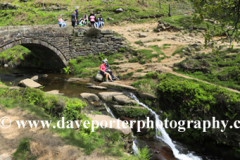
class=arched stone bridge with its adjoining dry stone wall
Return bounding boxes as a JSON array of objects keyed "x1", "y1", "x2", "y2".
[{"x1": 0, "y1": 26, "x2": 125, "y2": 68}]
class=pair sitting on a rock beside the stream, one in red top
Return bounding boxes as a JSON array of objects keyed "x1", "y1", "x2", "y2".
[{"x1": 100, "y1": 58, "x2": 118, "y2": 82}]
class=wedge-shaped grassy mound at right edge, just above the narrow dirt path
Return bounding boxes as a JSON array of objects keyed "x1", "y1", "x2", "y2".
[{"x1": 175, "y1": 49, "x2": 240, "y2": 90}]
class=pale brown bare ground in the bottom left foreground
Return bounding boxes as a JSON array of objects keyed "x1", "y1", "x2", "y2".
[{"x1": 0, "y1": 107, "x2": 120, "y2": 160}]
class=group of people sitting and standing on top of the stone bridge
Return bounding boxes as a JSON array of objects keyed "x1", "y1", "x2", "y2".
[{"x1": 58, "y1": 7, "x2": 104, "y2": 29}]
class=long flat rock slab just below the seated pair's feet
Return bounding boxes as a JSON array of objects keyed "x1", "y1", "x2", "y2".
[{"x1": 99, "y1": 82, "x2": 138, "y2": 92}]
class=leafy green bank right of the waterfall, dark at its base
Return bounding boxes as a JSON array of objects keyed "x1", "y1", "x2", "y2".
[{"x1": 157, "y1": 74, "x2": 240, "y2": 158}]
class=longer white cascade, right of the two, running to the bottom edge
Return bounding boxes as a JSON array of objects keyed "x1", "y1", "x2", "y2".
[{"x1": 126, "y1": 93, "x2": 202, "y2": 160}]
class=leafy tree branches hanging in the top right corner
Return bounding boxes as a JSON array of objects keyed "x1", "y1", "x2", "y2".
[{"x1": 193, "y1": 0, "x2": 240, "y2": 47}]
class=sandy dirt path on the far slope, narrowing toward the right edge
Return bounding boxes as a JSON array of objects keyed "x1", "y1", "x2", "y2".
[{"x1": 104, "y1": 22, "x2": 240, "y2": 93}]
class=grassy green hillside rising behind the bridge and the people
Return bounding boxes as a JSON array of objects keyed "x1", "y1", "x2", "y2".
[{"x1": 0, "y1": 0, "x2": 191, "y2": 26}]
